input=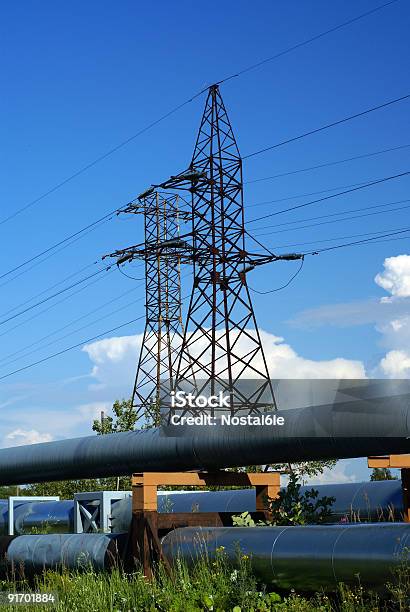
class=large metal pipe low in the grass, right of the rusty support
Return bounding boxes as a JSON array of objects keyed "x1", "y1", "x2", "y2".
[{"x1": 162, "y1": 523, "x2": 410, "y2": 591}]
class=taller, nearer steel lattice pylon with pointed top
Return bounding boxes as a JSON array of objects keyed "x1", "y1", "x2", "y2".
[{"x1": 168, "y1": 85, "x2": 276, "y2": 414}]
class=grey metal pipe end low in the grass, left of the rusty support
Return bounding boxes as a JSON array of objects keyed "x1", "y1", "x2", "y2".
[{"x1": 4, "y1": 533, "x2": 125, "y2": 575}]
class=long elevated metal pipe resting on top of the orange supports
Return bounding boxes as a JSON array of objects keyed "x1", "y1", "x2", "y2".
[{"x1": 0, "y1": 396, "x2": 410, "y2": 484}]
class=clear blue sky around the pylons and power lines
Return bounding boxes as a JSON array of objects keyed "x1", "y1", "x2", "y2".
[{"x1": 0, "y1": 0, "x2": 410, "y2": 482}]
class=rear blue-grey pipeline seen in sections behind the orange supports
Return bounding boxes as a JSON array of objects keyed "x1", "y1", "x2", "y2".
[{"x1": 0, "y1": 480, "x2": 403, "y2": 535}]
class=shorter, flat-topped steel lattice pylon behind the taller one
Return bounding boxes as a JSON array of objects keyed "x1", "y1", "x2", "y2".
[{"x1": 104, "y1": 194, "x2": 191, "y2": 424}]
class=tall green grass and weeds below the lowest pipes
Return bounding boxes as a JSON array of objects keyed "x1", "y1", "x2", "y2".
[{"x1": 0, "y1": 550, "x2": 410, "y2": 612}]
